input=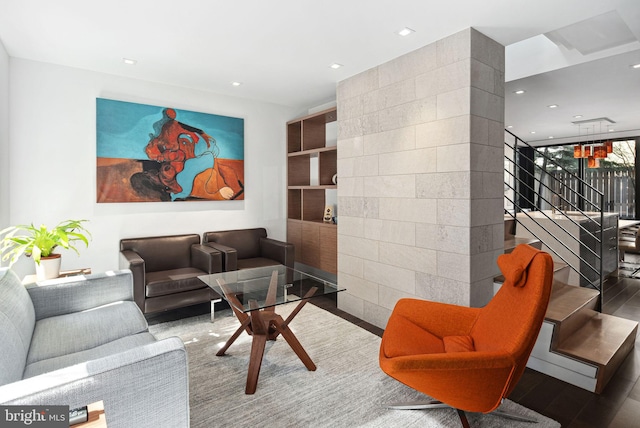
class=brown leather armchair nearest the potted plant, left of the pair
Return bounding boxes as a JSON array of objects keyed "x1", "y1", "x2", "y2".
[{"x1": 120, "y1": 234, "x2": 222, "y2": 319}]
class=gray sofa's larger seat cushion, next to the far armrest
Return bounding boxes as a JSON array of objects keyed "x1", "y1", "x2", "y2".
[{"x1": 27, "y1": 301, "x2": 147, "y2": 364}]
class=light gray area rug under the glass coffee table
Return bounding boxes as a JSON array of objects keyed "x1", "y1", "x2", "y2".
[{"x1": 149, "y1": 304, "x2": 560, "y2": 428}]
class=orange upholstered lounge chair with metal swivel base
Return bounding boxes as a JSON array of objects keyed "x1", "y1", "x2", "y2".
[{"x1": 380, "y1": 244, "x2": 553, "y2": 427}]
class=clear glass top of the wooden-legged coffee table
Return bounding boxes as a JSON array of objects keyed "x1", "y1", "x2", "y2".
[{"x1": 198, "y1": 265, "x2": 345, "y2": 312}]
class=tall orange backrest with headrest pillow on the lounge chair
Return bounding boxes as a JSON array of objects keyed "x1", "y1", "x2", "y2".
[{"x1": 471, "y1": 245, "x2": 553, "y2": 396}]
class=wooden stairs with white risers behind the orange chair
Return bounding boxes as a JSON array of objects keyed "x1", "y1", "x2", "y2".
[{"x1": 504, "y1": 240, "x2": 638, "y2": 394}]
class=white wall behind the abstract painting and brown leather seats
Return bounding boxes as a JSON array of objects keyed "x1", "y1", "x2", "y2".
[{"x1": 7, "y1": 58, "x2": 295, "y2": 275}]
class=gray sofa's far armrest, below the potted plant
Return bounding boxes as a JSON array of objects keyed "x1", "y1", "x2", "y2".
[{"x1": 26, "y1": 270, "x2": 133, "y2": 320}]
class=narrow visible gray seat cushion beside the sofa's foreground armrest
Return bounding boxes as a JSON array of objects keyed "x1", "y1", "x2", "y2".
[{"x1": 24, "y1": 332, "x2": 156, "y2": 379}]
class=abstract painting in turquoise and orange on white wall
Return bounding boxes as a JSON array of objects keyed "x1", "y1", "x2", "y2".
[{"x1": 96, "y1": 98, "x2": 244, "y2": 202}]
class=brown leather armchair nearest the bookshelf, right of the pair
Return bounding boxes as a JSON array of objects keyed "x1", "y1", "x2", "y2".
[{"x1": 202, "y1": 227, "x2": 295, "y2": 272}]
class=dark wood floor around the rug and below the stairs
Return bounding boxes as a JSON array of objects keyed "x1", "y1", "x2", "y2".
[{"x1": 147, "y1": 254, "x2": 640, "y2": 428}]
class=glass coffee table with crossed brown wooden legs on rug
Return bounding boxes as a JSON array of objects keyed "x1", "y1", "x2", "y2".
[{"x1": 198, "y1": 265, "x2": 344, "y2": 394}]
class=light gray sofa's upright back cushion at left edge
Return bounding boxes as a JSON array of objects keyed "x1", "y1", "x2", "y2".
[{"x1": 0, "y1": 269, "x2": 36, "y2": 385}]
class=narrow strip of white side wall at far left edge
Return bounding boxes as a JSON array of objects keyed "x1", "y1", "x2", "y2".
[{"x1": 0, "y1": 42, "x2": 9, "y2": 229}]
